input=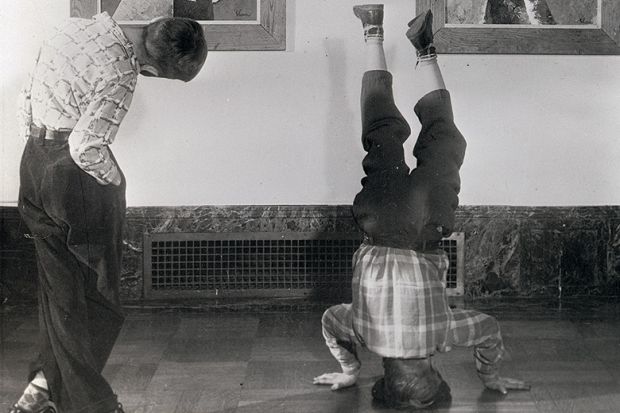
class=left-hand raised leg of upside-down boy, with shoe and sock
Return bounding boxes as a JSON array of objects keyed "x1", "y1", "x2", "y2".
[{"x1": 353, "y1": 4, "x2": 411, "y2": 242}]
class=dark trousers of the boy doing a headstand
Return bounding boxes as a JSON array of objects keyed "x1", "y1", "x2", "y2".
[{"x1": 353, "y1": 70, "x2": 466, "y2": 251}]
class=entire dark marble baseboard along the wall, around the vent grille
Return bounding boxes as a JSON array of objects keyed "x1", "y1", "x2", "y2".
[{"x1": 0, "y1": 205, "x2": 620, "y2": 300}]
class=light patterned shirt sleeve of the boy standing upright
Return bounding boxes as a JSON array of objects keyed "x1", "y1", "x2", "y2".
[{"x1": 69, "y1": 74, "x2": 136, "y2": 185}]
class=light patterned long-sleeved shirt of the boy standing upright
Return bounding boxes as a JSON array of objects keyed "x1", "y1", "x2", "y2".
[{"x1": 18, "y1": 13, "x2": 139, "y2": 184}]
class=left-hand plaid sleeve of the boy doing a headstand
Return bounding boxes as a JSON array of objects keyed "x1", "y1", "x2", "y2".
[{"x1": 321, "y1": 304, "x2": 362, "y2": 375}]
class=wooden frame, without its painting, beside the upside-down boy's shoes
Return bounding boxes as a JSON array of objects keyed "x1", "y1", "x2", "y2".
[{"x1": 416, "y1": 0, "x2": 620, "y2": 55}]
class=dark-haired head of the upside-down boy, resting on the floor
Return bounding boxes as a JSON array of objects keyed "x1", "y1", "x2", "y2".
[{"x1": 372, "y1": 357, "x2": 451, "y2": 409}]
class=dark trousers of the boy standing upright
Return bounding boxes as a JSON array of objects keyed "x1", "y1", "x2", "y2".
[{"x1": 19, "y1": 137, "x2": 125, "y2": 413}]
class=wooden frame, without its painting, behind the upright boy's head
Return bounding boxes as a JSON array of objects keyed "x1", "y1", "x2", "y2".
[{"x1": 70, "y1": 0, "x2": 286, "y2": 51}]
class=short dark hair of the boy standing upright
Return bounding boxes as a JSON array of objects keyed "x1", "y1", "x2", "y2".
[{"x1": 144, "y1": 17, "x2": 207, "y2": 82}]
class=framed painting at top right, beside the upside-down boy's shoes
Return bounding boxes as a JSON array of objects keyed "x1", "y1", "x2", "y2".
[{"x1": 416, "y1": 0, "x2": 620, "y2": 55}]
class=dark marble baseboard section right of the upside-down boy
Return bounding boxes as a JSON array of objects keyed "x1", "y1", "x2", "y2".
[{"x1": 455, "y1": 206, "x2": 620, "y2": 298}]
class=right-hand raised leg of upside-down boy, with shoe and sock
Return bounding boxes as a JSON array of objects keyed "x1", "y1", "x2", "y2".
[{"x1": 407, "y1": 10, "x2": 466, "y2": 245}]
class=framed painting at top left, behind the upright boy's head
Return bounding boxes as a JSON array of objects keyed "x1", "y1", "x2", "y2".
[{"x1": 70, "y1": 0, "x2": 286, "y2": 51}]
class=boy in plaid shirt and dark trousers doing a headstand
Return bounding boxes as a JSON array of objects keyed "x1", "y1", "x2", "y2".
[{"x1": 314, "y1": 4, "x2": 529, "y2": 408}]
